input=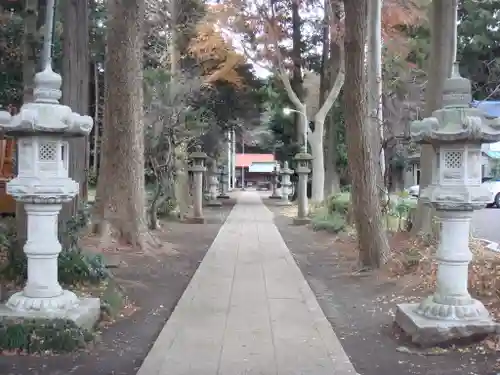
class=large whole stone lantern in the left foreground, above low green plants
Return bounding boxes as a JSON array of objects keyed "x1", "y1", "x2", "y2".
[{"x1": 0, "y1": 65, "x2": 100, "y2": 327}]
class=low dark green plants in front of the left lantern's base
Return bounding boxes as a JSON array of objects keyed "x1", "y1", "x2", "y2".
[{"x1": 0, "y1": 319, "x2": 94, "y2": 354}]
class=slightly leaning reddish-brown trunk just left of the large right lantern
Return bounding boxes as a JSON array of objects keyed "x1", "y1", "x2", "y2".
[{"x1": 344, "y1": 0, "x2": 389, "y2": 268}]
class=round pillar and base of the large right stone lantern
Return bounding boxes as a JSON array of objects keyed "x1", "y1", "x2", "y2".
[{"x1": 396, "y1": 211, "x2": 500, "y2": 346}]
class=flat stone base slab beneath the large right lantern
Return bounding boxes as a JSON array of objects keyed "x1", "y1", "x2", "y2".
[{"x1": 395, "y1": 303, "x2": 500, "y2": 347}]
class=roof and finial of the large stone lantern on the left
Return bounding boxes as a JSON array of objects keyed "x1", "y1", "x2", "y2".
[{"x1": 0, "y1": 66, "x2": 93, "y2": 137}]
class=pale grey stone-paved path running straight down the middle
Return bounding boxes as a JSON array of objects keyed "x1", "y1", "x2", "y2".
[{"x1": 137, "y1": 192, "x2": 356, "y2": 375}]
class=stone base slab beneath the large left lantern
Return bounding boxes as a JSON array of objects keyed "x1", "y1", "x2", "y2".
[{"x1": 0, "y1": 296, "x2": 101, "y2": 330}]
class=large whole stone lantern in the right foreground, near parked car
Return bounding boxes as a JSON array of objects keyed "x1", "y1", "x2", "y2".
[{"x1": 396, "y1": 64, "x2": 500, "y2": 345}]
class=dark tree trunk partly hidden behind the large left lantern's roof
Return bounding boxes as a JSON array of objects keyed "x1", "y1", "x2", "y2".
[{"x1": 59, "y1": 0, "x2": 90, "y2": 241}]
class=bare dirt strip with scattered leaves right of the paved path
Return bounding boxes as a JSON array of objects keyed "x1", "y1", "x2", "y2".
[{"x1": 268, "y1": 204, "x2": 500, "y2": 375}]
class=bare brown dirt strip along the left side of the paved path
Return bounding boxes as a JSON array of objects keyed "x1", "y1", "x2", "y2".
[{"x1": 0, "y1": 200, "x2": 235, "y2": 375}]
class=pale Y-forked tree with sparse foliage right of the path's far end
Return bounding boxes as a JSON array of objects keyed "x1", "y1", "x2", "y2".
[{"x1": 225, "y1": 0, "x2": 344, "y2": 202}]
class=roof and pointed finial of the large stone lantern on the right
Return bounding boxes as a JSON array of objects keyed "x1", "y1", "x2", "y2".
[{"x1": 410, "y1": 63, "x2": 500, "y2": 145}]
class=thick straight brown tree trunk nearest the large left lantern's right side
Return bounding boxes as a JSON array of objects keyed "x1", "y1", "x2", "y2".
[{"x1": 95, "y1": 0, "x2": 148, "y2": 248}]
